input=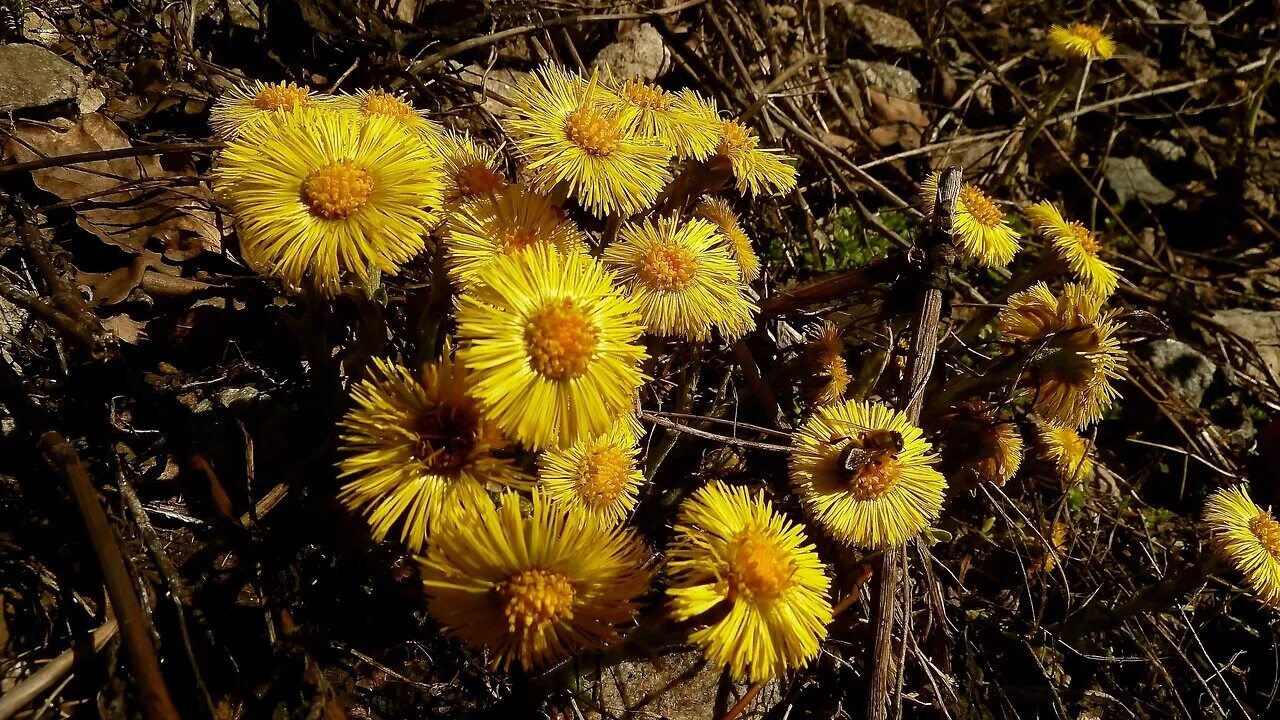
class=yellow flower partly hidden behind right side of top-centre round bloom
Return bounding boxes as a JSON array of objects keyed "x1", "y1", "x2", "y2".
[{"x1": 600, "y1": 78, "x2": 719, "y2": 160}]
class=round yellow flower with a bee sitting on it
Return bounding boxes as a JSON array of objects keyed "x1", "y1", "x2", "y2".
[{"x1": 791, "y1": 400, "x2": 947, "y2": 548}]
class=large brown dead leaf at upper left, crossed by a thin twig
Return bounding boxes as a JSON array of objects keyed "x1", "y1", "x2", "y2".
[{"x1": 4, "y1": 113, "x2": 223, "y2": 260}]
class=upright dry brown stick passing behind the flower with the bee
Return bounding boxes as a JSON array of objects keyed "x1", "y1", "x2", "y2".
[{"x1": 867, "y1": 165, "x2": 960, "y2": 720}]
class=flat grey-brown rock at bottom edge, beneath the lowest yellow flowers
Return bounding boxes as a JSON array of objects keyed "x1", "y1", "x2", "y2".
[{"x1": 582, "y1": 651, "x2": 778, "y2": 720}]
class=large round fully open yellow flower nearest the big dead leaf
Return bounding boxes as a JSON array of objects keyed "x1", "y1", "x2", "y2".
[{"x1": 214, "y1": 110, "x2": 440, "y2": 293}]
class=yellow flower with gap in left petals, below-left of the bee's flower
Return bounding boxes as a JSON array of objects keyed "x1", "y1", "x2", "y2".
[{"x1": 667, "y1": 482, "x2": 832, "y2": 680}]
